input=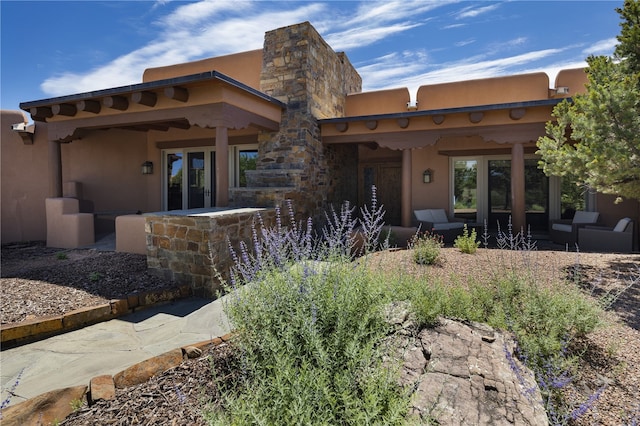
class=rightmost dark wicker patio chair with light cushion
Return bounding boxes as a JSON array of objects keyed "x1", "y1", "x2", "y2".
[{"x1": 578, "y1": 217, "x2": 633, "y2": 253}]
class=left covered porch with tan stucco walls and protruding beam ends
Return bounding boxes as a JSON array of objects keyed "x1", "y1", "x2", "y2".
[{"x1": 21, "y1": 71, "x2": 284, "y2": 247}]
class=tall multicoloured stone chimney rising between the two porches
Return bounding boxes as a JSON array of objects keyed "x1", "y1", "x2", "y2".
[{"x1": 238, "y1": 22, "x2": 362, "y2": 220}]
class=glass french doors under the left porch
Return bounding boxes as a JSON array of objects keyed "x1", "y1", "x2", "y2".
[{"x1": 163, "y1": 148, "x2": 216, "y2": 210}]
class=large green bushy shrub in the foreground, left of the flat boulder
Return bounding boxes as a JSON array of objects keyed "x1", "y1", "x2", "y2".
[{"x1": 208, "y1": 261, "x2": 409, "y2": 425}]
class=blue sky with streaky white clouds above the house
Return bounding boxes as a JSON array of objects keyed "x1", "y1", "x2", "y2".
[{"x1": 0, "y1": 0, "x2": 623, "y2": 109}]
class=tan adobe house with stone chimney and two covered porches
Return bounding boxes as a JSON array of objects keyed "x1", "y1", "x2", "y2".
[{"x1": 2, "y1": 22, "x2": 640, "y2": 290}]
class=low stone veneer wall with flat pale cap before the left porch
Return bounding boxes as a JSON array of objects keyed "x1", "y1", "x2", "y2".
[{"x1": 145, "y1": 208, "x2": 275, "y2": 297}]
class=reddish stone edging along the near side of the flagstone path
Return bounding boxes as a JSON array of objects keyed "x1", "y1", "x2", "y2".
[{"x1": 1, "y1": 333, "x2": 232, "y2": 426}]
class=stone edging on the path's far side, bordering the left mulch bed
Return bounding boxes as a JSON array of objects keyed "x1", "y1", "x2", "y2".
[{"x1": 0, "y1": 285, "x2": 192, "y2": 350}]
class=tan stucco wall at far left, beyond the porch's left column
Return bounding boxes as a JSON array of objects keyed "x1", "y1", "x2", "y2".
[{"x1": 0, "y1": 110, "x2": 49, "y2": 244}]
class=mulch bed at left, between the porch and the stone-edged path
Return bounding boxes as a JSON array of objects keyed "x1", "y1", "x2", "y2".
[{"x1": 0, "y1": 242, "x2": 180, "y2": 324}]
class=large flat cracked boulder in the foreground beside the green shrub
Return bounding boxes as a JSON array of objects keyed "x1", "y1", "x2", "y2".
[{"x1": 396, "y1": 319, "x2": 549, "y2": 426}]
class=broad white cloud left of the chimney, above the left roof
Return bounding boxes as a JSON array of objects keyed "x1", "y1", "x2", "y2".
[{"x1": 40, "y1": 1, "x2": 324, "y2": 96}]
